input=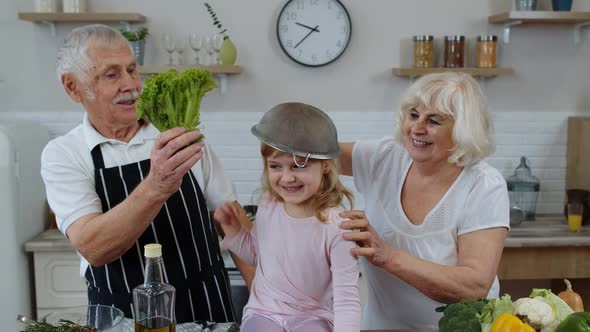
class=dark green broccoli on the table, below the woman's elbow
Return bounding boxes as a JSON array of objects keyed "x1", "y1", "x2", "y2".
[{"x1": 436, "y1": 299, "x2": 488, "y2": 332}]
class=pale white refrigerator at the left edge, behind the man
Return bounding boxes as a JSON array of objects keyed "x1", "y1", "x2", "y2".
[{"x1": 0, "y1": 121, "x2": 50, "y2": 331}]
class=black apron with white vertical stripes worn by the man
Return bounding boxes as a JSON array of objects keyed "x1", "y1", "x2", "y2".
[{"x1": 85, "y1": 145, "x2": 235, "y2": 323}]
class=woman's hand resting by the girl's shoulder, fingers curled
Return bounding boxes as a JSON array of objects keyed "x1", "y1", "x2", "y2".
[{"x1": 340, "y1": 210, "x2": 394, "y2": 268}]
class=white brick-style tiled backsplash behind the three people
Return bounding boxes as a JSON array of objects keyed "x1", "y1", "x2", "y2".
[{"x1": 0, "y1": 112, "x2": 575, "y2": 213}]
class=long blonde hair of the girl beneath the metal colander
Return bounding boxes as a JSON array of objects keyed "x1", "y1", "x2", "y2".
[{"x1": 260, "y1": 143, "x2": 354, "y2": 222}]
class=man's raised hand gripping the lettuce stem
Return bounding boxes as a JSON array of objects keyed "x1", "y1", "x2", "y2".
[{"x1": 146, "y1": 127, "x2": 205, "y2": 197}]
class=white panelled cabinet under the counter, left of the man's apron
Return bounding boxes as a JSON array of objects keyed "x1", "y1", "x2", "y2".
[{"x1": 25, "y1": 229, "x2": 88, "y2": 319}]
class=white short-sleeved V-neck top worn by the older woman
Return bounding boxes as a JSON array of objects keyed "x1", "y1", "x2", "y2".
[{"x1": 352, "y1": 137, "x2": 509, "y2": 331}]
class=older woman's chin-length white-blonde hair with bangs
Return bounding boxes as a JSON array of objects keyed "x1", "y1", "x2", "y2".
[{"x1": 396, "y1": 72, "x2": 495, "y2": 166}]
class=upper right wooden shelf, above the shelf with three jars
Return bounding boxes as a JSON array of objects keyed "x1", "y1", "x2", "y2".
[{"x1": 488, "y1": 11, "x2": 590, "y2": 24}]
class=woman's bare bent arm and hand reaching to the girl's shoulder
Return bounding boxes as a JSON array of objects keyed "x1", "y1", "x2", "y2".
[{"x1": 341, "y1": 211, "x2": 508, "y2": 303}]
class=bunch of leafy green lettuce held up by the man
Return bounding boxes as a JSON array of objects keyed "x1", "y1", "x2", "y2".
[{"x1": 137, "y1": 68, "x2": 217, "y2": 132}]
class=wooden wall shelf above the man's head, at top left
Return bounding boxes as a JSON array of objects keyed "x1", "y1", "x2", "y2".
[{"x1": 18, "y1": 13, "x2": 146, "y2": 23}]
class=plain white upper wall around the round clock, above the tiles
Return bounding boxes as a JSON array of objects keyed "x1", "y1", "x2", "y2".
[{"x1": 0, "y1": 0, "x2": 590, "y2": 112}]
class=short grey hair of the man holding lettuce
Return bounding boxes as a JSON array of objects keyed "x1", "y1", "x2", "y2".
[{"x1": 56, "y1": 24, "x2": 128, "y2": 82}]
